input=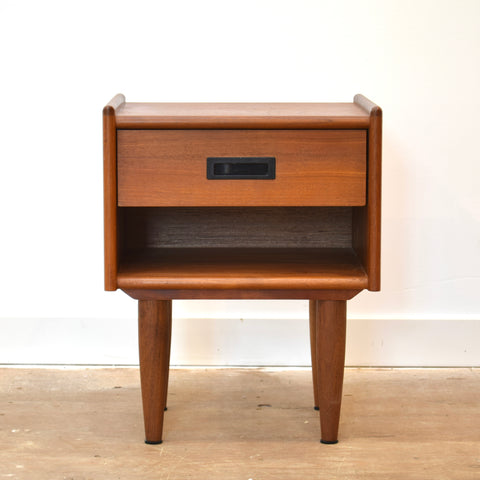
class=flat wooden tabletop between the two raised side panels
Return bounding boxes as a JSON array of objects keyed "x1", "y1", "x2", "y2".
[{"x1": 117, "y1": 102, "x2": 370, "y2": 129}]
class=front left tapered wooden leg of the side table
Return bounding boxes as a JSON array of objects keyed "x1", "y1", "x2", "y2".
[{"x1": 138, "y1": 300, "x2": 172, "y2": 444}]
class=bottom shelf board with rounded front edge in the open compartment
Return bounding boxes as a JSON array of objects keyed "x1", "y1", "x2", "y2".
[{"x1": 118, "y1": 248, "x2": 368, "y2": 290}]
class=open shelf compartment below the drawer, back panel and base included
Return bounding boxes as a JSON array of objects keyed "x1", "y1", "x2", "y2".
[{"x1": 118, "y1": 207, "x2": 368, "y2": 290}]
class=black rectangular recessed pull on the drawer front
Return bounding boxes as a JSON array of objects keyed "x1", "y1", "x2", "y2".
[{"x1": 207, "y1": 157, "x2": 275, "y2": 180}]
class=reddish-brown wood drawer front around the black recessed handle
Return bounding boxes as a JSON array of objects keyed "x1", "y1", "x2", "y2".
[{"x1": 117, "y1": 130, "x2": 367, "y2": 207}]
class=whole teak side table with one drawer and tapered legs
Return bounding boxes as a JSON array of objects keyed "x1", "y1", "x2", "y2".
[{"x1": 103, "y1": 95, "x2": 382, "y2": 443}]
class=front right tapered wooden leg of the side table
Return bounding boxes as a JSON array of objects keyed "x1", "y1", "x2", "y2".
[{"x1": 316, "y1": 300, "x2": 347, "y2": 443}]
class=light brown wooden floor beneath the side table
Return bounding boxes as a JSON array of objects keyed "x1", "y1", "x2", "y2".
[{"x1": 0, "y1": 368, "x2": 480, "y2": 480}]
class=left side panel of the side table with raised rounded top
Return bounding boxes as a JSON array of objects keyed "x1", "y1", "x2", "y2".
[{"x1": 103, "y1": 94, "x2": 125, "y2": 291}]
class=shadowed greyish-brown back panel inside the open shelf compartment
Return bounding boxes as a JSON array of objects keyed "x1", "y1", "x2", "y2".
[{"x1": 118, "y1": 207, "x2": 352, "y2": 251}]
